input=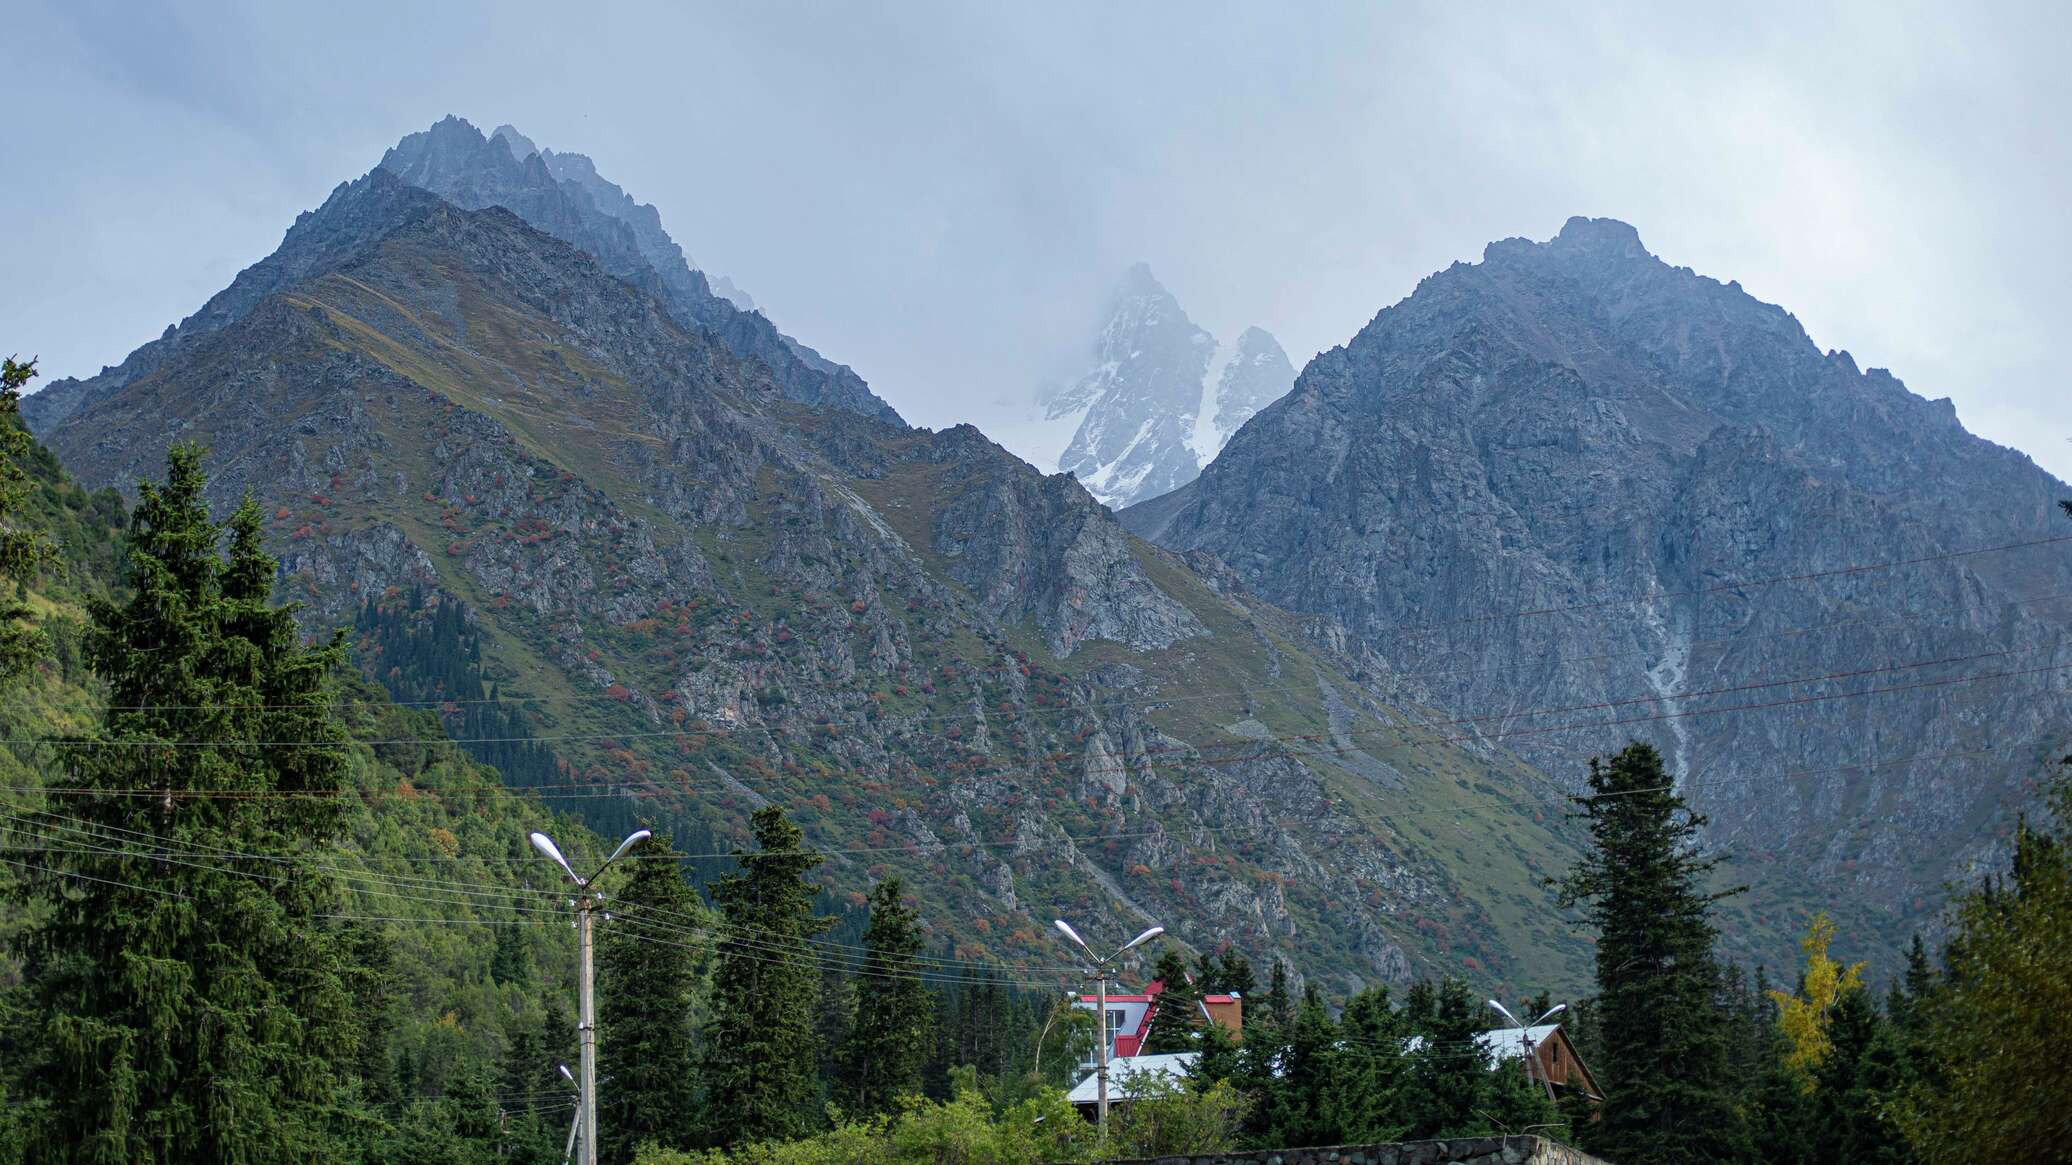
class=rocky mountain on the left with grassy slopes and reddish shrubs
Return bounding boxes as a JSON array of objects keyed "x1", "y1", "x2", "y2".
[{"x1": 20, "y1": 133, "x2": 1587, "y2": 989}]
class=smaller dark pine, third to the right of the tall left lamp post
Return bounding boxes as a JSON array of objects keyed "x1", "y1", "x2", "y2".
[{"x1": 835, "y1": 877, "x2": 934, "y2": 1117}]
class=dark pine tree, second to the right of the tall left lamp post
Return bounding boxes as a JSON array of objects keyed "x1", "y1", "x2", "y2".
[{"x1": 698, "y1": 806, "x2": 829, "y2": 1144}]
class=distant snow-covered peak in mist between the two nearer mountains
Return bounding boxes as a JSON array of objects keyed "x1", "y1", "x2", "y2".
[{"x1": 1038, "y1": 263, "x2": 1295, "y2": 508}]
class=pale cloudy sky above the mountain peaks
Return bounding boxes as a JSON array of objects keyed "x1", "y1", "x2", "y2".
[{"x1": 0, "y1": 0, "x2": 2072, "y2": 479}]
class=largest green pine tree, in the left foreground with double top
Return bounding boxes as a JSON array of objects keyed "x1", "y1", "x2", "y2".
[{"x1": 19, "y1": 446, "x2": 361, "y2": 1163}]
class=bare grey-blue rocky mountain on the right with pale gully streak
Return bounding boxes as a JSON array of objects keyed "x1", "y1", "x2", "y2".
[{"x1": 1123, "y1": 218, "x2": 2072, "y2": 951}]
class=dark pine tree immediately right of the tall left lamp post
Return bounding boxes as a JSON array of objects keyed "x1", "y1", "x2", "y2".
[{"x1": 597, "y1": 833, "x2": 704, "y2": 1163}]
